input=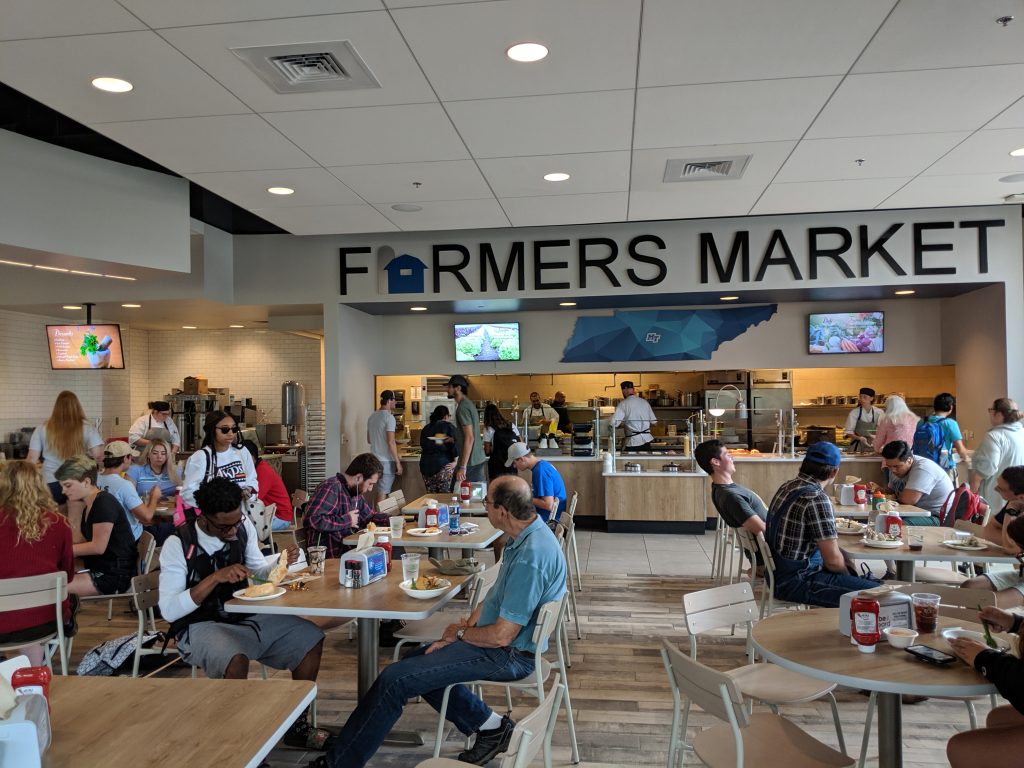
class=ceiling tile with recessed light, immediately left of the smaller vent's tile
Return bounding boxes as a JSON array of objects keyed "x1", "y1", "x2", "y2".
[{"x1": 479, "y1": 152, "x2": 630, "y2": 198}]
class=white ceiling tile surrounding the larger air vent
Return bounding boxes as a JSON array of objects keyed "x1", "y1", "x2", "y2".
[{"x1": 161, "y1": 11, "x2": 437, "y2": 112}]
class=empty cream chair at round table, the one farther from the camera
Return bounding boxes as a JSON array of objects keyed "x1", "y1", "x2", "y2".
[{"x1": 670, "y1": 582, "x2": 846, "y2": 765}]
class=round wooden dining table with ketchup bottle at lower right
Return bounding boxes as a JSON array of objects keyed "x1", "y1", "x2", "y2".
[{"x1": 753, "y1": 608, "x2": 995, "y2": 768}]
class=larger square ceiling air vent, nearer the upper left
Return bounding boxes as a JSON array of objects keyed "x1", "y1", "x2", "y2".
[{"x1": 231, "y1": 40, "x2": 381, "y2": 93}]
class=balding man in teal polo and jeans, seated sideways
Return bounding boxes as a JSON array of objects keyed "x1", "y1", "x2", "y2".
[{"x1": 309, "y1": 475, "x2": 565, "y2": 768}]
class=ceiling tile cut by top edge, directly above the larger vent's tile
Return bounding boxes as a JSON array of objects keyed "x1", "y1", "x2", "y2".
[{"x1": 120, "y1": 0, "x2": 383, "y2": 28}]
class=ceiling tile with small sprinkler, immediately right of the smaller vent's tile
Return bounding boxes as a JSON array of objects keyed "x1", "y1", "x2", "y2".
[{"x1": 775, "y1": 132, "x2": 969, "y2": 182}]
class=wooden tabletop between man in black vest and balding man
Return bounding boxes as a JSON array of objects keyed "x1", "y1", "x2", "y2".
[{"x1": 224, "y1": 559, "x2": 470, "y2": 622}]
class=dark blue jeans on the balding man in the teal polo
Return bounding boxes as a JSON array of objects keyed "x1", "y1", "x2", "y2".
[{"x1": 327, "y1": 641, "x2": 534, "y2": 768}]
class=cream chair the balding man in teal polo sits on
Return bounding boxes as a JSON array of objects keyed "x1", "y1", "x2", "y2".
[{"x1": 434, "y1": 595, "x2": 580, "y2": 768}]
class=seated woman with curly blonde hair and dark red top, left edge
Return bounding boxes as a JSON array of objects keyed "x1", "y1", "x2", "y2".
[{"x1": 0, "y1": 461, "x2": 75, "y2": 666}]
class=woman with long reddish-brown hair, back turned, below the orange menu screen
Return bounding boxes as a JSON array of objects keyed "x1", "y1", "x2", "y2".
[{"x1": 27, "y1": 389, "x2": 103, "y2": 504}]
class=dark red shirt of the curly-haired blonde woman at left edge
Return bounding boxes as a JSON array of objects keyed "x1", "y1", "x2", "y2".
[{"x1": 0, "y1": 509, "x2": 75, "y2": 635}]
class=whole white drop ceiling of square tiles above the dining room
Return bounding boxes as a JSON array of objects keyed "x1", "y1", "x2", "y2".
[{"x1": 0, "y1": 0, "x2": 1024, "y2": 234}]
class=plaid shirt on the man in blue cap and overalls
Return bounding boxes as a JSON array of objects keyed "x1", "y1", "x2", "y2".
[{"x1": 768, "y1": 474, "x2": 839, "y2": 560}]
